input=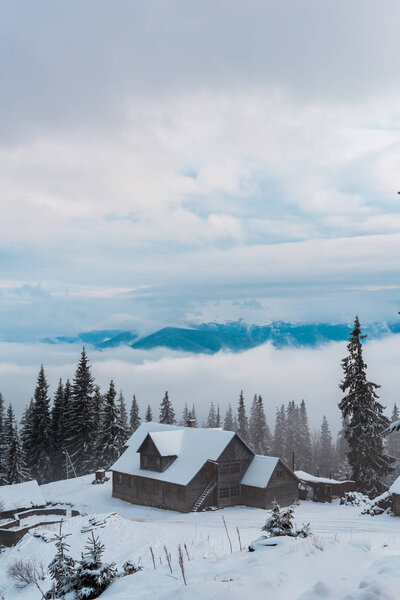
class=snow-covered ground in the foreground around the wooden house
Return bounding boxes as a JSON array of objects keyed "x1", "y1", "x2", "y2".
[{"x1": 0, "y1": 476, "x2": 400, "y2": 600}]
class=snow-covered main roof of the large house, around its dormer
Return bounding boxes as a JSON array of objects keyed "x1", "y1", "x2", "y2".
[{"x1": 111, "y1": 422, "x2": 235, "y2": 485}]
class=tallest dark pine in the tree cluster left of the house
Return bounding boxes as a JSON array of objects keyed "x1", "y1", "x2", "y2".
[{"x1": 68, "y1": 348, "x2": 97, "y2": 475}]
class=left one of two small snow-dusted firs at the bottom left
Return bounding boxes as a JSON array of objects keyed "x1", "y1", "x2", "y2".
[{"x1": 48, "y1": 523, "x2": 75, "y2": 600}]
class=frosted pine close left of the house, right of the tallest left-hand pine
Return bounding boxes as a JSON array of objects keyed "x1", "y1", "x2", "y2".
[{"x1": 96, "y1": 380, "x2": 126, "y2": 469}]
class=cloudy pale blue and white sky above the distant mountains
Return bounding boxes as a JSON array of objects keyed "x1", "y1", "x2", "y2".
[{"x1": 0, "y1": 0, "x2": 400, "y2": 422}]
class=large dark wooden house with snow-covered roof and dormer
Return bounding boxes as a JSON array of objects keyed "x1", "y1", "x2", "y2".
[{"x1": 111, "y1": 423, "x2": 298, "y2": 512}]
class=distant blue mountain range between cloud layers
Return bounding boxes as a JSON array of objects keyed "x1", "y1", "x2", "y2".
[{"x1": 39, "y1": 321, "x2": 400, "y2": 354}]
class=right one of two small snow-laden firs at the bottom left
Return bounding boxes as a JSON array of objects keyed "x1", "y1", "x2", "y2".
[{"x1": 73, "y1": 531, "x2": 117, "y2": 600}]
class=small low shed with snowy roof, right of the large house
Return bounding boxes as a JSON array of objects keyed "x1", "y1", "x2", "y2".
[{"x1": 295, "y1": 471, "x2": 356, "y2": 502}]
